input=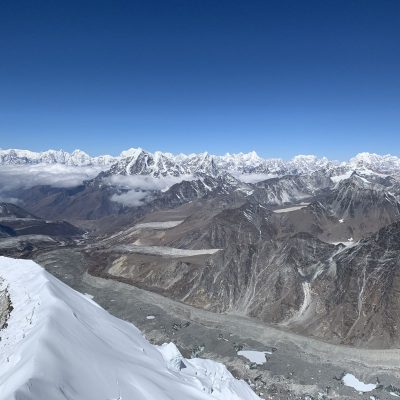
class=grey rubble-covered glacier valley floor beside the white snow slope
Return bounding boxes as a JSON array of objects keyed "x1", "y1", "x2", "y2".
[{"x1": 35, "y1": 249, "x2": 400, "y2": 400}]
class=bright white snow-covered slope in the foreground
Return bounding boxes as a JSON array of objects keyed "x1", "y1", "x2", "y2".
[{"x1": 0, "y1": 257, "x2": 258, "y2": 400}]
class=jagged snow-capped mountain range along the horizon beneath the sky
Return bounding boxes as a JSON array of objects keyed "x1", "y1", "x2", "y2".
[{"x1": 0, "y1": 148, "x2": 400, "y2": 177}]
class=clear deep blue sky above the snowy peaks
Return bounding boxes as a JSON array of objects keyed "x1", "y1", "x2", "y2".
[{"x1": 0, "y1": 0, "x2": 400, "y2": 159}]
